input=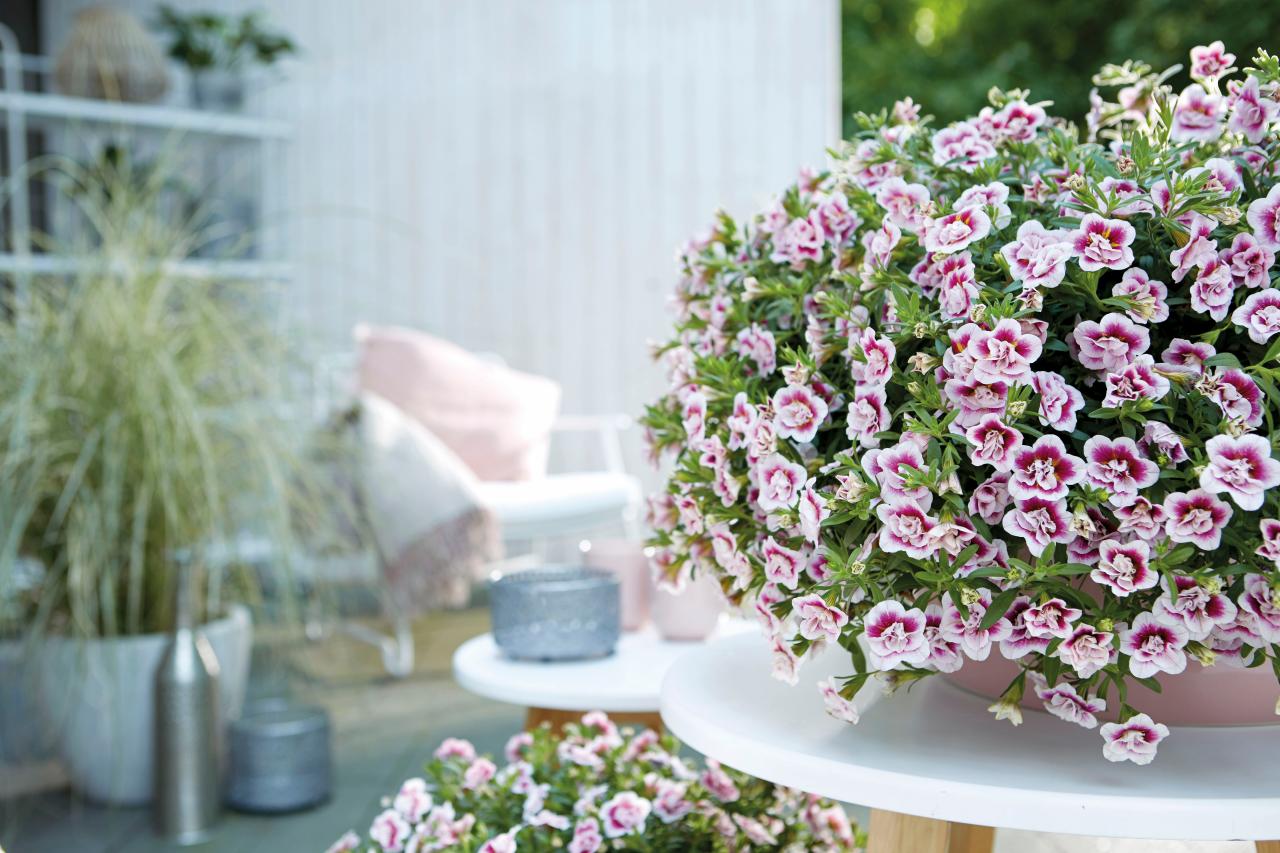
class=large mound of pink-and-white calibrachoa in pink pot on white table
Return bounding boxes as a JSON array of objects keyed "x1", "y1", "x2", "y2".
[{"x1": 646, "y1": 42, "x2": 1280, "y2": 763}]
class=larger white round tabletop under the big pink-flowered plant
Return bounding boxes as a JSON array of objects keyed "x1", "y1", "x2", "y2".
[{"x1": 662, "y1": 627, "x2": 1280, "y2": 840}]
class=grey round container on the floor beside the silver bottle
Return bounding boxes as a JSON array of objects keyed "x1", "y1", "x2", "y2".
[{"x1": 227, "y1": 701, "x2": 333, "y2": 815}]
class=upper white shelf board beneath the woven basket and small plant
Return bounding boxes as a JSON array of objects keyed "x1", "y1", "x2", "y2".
[{"x1": 0, "y1": 91, "x2": 291, "y2": 140}]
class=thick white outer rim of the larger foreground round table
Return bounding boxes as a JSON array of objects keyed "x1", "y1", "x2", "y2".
[{"x1": 660, "y1": 635, "x2": 1280, "y2": 841}]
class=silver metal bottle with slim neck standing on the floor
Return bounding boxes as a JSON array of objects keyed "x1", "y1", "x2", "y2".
[{"x1": 155, "y1": 565, "x2": 221, "y2": 845}]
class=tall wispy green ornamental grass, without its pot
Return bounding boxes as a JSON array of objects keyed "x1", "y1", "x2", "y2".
[{"x1": 0, "y1": 152, "x2": 348, "y2": 637}]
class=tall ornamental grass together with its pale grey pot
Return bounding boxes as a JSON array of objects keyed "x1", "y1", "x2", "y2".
[{"x1": 0, "y1": 159, "x2": 335, "y2": 803}]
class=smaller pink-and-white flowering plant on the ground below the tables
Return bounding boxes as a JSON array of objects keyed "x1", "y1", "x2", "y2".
[{"x1": 329, "y1": 712, "x2": 865, "y2": 853}]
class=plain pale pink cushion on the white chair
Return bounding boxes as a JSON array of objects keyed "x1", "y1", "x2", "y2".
[{"x1": 356, "y1": 324, "x2": 561, "y2": 480}]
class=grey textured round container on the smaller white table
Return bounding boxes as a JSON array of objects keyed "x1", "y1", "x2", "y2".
[{"x1": 489, "y1": 566, "x2": 621, "y2": 661}]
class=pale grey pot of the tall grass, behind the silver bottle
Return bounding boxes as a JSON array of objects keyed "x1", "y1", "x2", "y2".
[{"x1": 37, "y1": 606, "x2": 253, "y2": 806}]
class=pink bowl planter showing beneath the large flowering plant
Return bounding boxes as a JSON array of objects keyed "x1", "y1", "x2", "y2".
[{"x1": 943, "y1": 652, "x2": 1280, "y2": 726}]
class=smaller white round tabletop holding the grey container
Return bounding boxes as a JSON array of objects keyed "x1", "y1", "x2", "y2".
[{"x1": 453, "y1": 619, "x2": 749, "y2": 712}]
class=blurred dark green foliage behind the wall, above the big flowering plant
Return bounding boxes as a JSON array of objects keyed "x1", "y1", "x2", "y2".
[{"x1": 842, "y1": 0, "x2": 1280, "y2": 133}]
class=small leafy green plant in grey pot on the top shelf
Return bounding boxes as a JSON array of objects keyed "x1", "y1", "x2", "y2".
[{"x1": 156, "y1": 5, "x2": 297, "y2": 111}]
